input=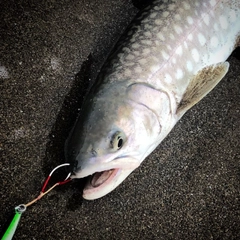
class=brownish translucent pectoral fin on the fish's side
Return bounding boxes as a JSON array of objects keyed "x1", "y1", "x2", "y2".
[{"x1": 176, "y1": 62, "x2": 229, "y2": 118}]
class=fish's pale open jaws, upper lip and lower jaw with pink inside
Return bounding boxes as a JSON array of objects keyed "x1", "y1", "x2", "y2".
[{"x1": 71, "y1": 157, "x2": 141, "y2": 200}]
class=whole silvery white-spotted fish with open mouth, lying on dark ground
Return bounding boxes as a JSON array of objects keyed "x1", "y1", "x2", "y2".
[{"x1": 65, "y1": 0, "x2": 240, "y2": 200}]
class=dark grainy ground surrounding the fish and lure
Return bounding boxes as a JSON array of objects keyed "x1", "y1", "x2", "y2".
[{"x1": 0, "y1": 0, "x2": 240, "y2": 239}]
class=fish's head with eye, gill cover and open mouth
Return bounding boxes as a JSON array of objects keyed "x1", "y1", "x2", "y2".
[{"x1": 66, "y1": 82, "x2": 165, "y2": 200}]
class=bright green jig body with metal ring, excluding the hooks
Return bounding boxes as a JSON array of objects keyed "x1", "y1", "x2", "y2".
[{"x1": 1, "y1": 204, "x2": 26, "y2": 240}]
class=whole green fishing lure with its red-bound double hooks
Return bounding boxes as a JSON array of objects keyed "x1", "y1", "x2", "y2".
[{"x1": 2, "y1": 163, "x2": 71, "y2": 240}]
